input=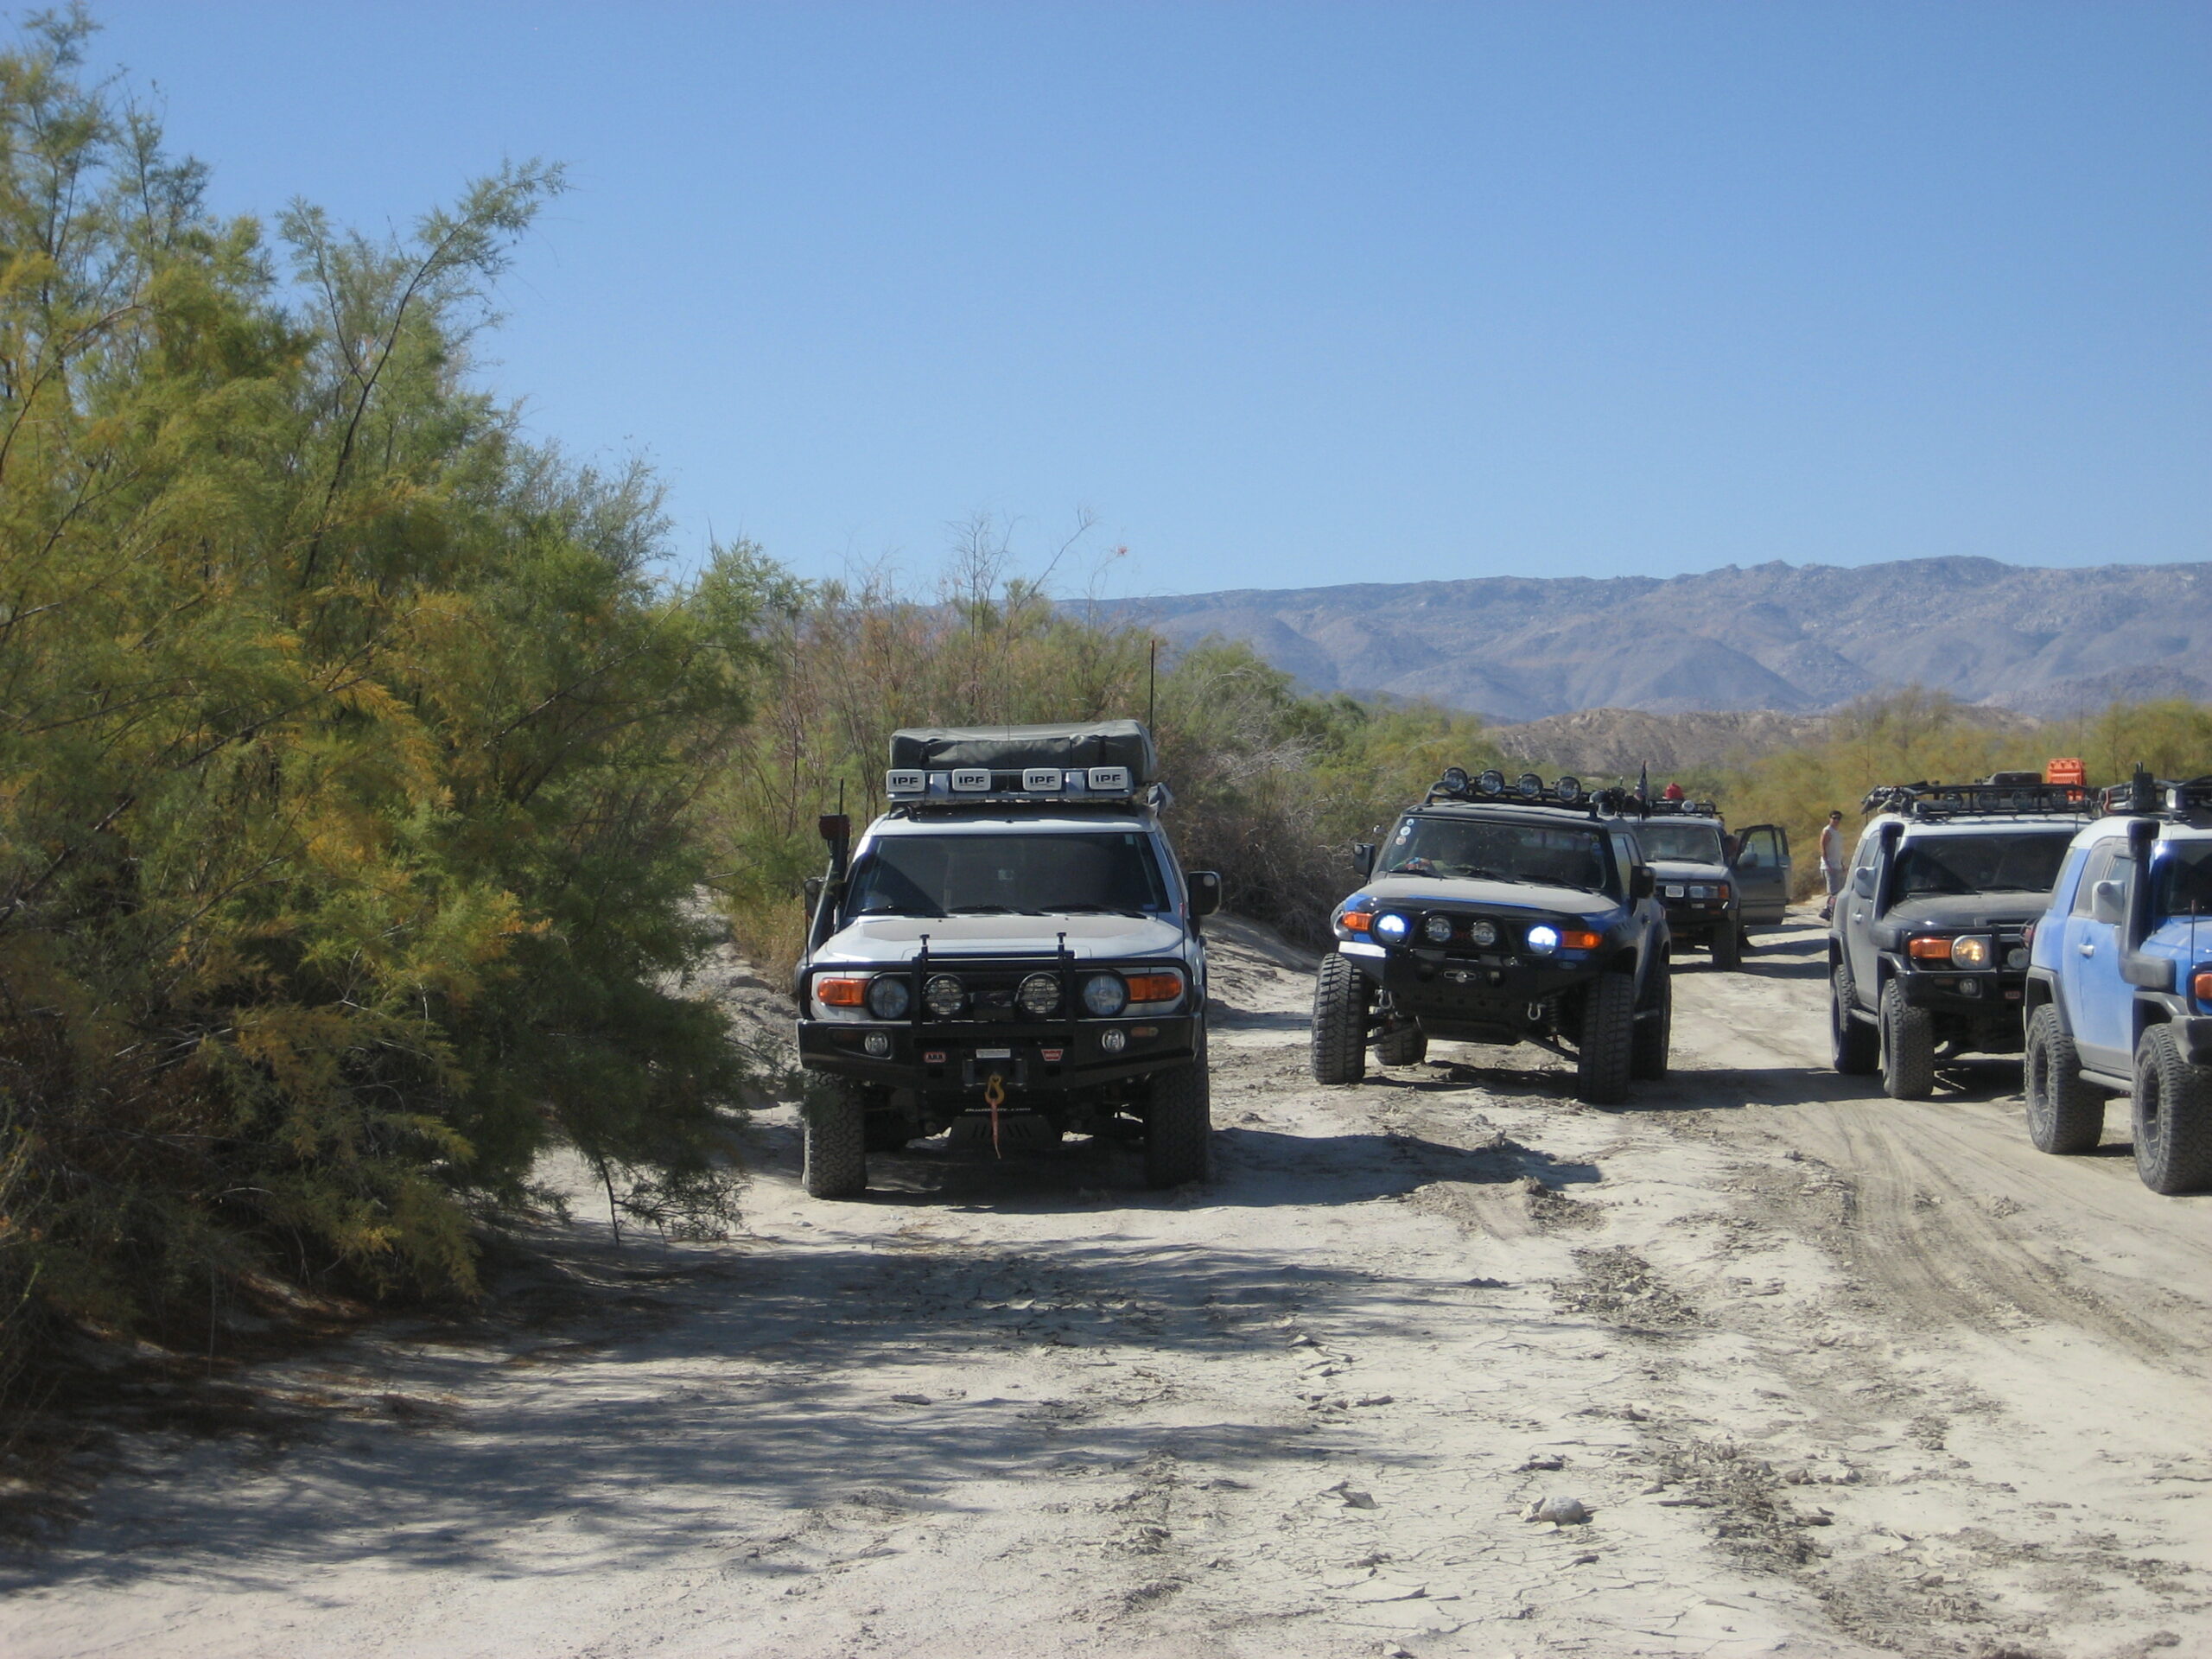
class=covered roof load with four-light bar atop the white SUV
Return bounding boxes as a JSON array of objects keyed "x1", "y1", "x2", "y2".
[{"x1": 885, "y1": 721, "x2": 1168, "y2": 805}]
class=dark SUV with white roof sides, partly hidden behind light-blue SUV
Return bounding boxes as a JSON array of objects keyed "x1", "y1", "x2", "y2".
[{"x1": 1827, "y1": 772, "x2": 2097, "y2": 1099}]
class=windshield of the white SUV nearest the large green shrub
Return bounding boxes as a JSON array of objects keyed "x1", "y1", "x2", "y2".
[{"x1": 845, "y1": 830, "x2": 1168, "y2": 916}]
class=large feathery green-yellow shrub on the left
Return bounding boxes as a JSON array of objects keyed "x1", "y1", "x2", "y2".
[{"x1": 0, "y1": 13, "x2": 757, "y2": 1380}]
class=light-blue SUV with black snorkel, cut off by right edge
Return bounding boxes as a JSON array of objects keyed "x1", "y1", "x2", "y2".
[{"x1": 2026, "y1": 770, "x2": 2212, "y2": 1192}]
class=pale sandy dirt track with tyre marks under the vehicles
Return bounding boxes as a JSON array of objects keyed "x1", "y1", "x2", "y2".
[{"x1": 0, "y1": 923, "x2": 2212, "y2": 1659}]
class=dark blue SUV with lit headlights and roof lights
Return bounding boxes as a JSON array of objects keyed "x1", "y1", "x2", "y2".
[{"x1": 1314, "y1": 767, "x2": 1675, "y2": 1103}]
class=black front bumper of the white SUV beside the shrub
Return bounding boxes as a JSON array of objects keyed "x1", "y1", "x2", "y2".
[{"x1": 798, "y1": 1013, "x2": 1199, "y2": 1095}]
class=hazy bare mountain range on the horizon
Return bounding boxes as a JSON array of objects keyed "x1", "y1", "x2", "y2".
[{"x1": 1106, "y1": 560, "x2": 2212, "y2": 721}]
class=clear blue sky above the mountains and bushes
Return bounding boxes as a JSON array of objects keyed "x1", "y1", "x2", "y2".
[{"x1": 64, "y1": 0, "x2": 2212, "y2": 593}]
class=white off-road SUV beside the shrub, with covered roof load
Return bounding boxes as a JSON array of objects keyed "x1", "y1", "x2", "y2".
[{"x1": 794, "y1": 721, "x2": 1221, "y2": 1199}]
